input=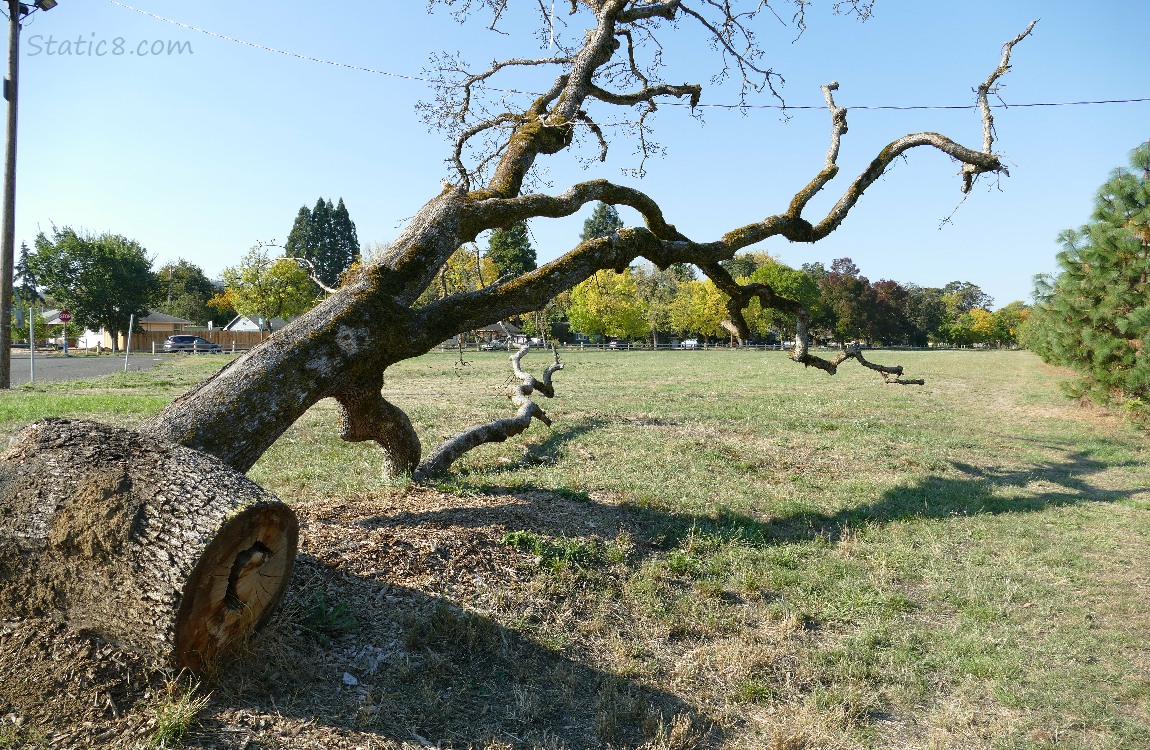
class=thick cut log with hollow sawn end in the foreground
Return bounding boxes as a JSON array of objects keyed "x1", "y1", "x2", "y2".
[{"x1": 0, "y1": 419, "x2": 299, "y2": 672}]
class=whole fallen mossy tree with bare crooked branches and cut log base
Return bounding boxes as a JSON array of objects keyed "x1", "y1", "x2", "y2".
[{"x1": 0, "y1": 0, "x2": 1033, "y2": 669}]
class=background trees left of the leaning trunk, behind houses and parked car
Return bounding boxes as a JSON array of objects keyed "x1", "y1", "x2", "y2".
[{"x1": 13, "y1": 198, "x2": 360, "y2": 346}]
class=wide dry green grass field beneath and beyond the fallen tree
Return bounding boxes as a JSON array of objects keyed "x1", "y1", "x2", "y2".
[{"x1": 0, "y1": 351, "x2": 1150, "y2": 750}]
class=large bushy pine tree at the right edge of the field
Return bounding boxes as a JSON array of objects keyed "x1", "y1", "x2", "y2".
[{"x1": 1027, "y1": 143, "x2": 1150, "y2": 404}]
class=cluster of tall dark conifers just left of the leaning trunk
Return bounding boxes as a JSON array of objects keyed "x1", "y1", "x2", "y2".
[{"x1": 284, "y1": 198, "x2": 360, "y2": 286}]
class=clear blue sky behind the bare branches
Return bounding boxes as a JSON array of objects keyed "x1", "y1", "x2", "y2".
[{"x1": 8, "y1": 0, "x2": 1150, "y2": 306}]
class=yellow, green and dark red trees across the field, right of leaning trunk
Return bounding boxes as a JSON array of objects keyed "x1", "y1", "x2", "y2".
[{"x1": 526, "y1": 202, "x2": 1027, "y2": 346}]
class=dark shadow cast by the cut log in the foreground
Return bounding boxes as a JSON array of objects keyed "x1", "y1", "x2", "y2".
[{"x1": 197, "y1": 554, "x2": 718, "y2": 748}]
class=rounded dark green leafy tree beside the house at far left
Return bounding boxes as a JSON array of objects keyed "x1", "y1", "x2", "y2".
[{"x1": 28, "y1": 227, "x2": 155, "y2": 350}]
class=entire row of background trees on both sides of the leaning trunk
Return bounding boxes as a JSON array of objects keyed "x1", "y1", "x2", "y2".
[{"x1": 14, "y1": 198, "x2": 1028, "y2": 354}]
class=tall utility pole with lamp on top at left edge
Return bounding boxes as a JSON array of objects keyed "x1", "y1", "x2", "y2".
[{"x1": 0, "y1": 0, "x2": 56, "y2": 389}]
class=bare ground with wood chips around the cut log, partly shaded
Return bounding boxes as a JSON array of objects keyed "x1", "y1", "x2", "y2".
[{"x1": 0, "y1": 489, "x2": 713, "y2": 750}]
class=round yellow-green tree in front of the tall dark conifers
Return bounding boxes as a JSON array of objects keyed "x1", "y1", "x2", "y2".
[{"x1": 217, "y1": 247, "x2": 315, "y2": 331}]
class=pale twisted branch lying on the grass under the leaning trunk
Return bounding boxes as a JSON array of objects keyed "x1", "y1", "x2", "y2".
[{"x1": 413, "y1": 346, "x2": 564, "y2": 481}]
